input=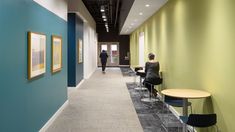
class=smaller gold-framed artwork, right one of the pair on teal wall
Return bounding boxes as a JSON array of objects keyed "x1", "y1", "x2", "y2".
[{"x1": 51, "y1": 35, "x2": 62, "y2": 73}]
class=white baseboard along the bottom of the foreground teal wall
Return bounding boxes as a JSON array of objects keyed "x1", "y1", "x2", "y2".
[{"x1": 39, "y1": 100, "x2": 69, "y2": 132}]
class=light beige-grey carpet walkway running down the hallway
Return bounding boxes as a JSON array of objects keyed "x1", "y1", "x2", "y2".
[{"x1": 47, "y1": 68, "x2": 143, "y2": 132}]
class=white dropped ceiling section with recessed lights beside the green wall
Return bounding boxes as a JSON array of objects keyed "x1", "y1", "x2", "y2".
[{"x1": 120, "y1": 0, "x2": 167, "y2": 35}]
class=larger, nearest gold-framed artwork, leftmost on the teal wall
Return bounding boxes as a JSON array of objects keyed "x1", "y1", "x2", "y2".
[{"x1": 28, "y1": 32, "x2": 46, "y2": 79}]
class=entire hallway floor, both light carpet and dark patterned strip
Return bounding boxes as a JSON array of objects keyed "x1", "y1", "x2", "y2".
[{"x1": 46, "y1": 68, "x2": 180, "y2": 132}]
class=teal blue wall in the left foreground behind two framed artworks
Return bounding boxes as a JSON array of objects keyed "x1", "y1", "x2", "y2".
[{"x1": 0, "y1": 0, "x2": 67, "y2": 132}]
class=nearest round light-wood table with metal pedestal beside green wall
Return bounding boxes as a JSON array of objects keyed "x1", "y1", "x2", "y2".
[{"x1": 161, "y1": 89, "x2": 211, "y2": 132}]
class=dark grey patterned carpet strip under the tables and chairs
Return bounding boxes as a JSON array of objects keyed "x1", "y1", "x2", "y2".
[{"x1": 126, "y1": 83, "x2": 182, "y2": 132}]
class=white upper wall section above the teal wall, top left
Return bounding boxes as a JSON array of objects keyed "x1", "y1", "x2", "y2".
[{"x1": 34, "y1": 0, "x2": 68, "y2": 21}]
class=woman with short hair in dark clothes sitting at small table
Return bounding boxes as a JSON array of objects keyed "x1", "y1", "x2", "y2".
[{"x1": 143, "y1": 53, "x2": 162, "y2": 97}]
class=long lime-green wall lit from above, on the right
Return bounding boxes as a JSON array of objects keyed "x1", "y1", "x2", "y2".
[{"x1": 130, "y1": 0, "x2": 235, "y2": 132}]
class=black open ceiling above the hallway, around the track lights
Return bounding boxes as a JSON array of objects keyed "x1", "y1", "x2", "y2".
[{"x1": 82, "y1": 0, "x2": 122, "y2": 27}]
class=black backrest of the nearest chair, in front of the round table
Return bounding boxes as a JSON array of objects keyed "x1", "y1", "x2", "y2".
[{"x1": 187, "y1": 114, "x2": 217, "y2": 127}]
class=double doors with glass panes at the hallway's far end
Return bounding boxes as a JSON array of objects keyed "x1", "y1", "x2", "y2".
[{"x1": 98, "y1": 42, "x2": 119, "y2": 67}]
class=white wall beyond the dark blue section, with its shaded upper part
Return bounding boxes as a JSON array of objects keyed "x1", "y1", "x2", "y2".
[{"x1": 68, "y1": 0, "x2": 97, "y2": 79}]
